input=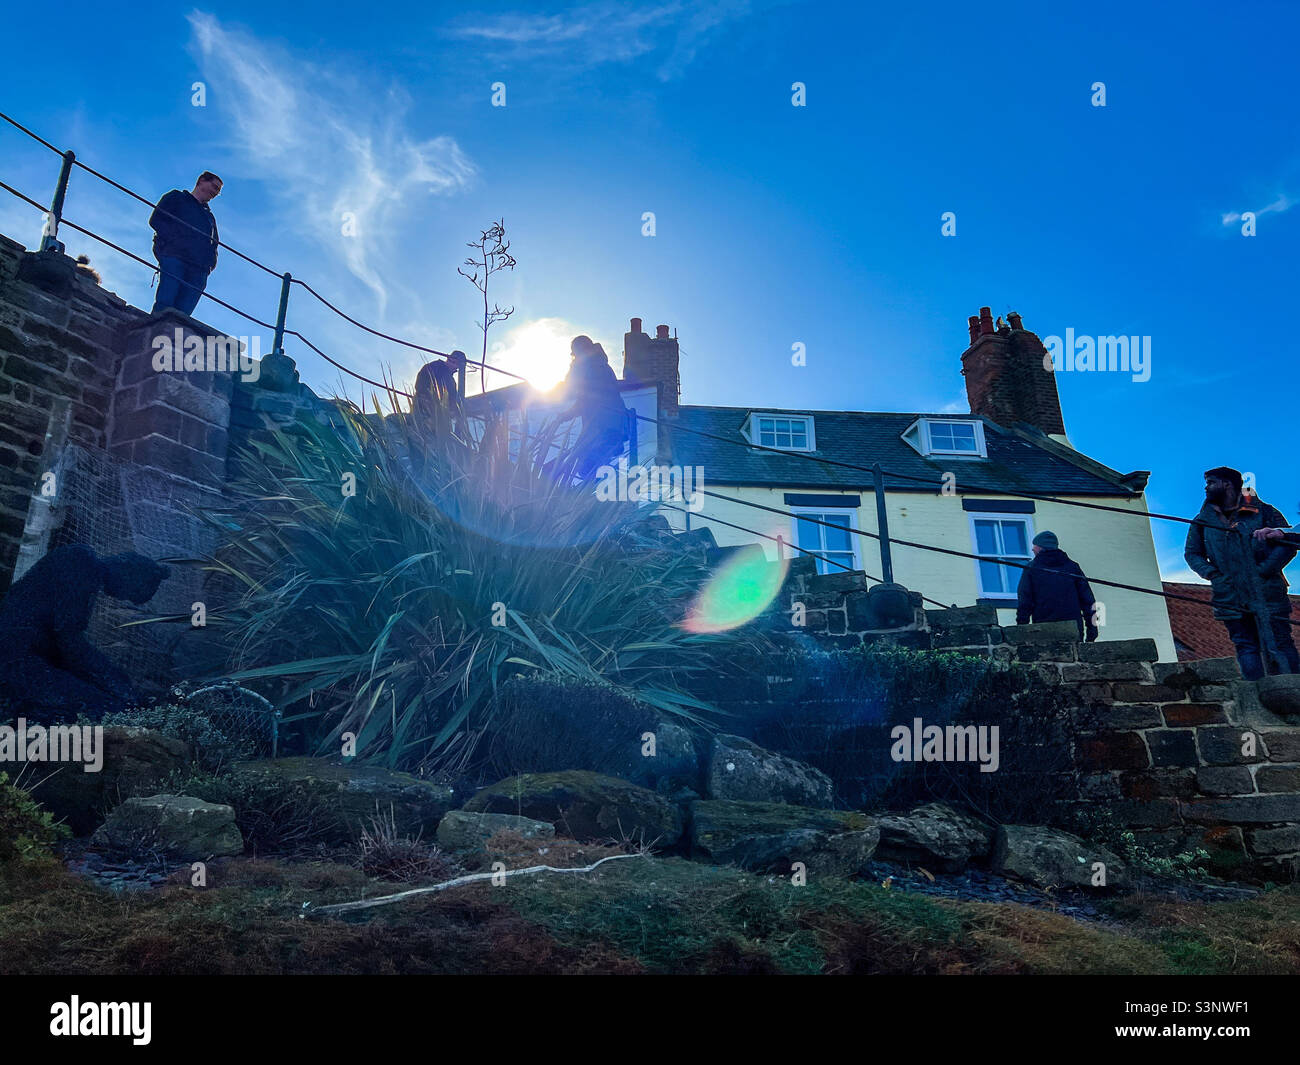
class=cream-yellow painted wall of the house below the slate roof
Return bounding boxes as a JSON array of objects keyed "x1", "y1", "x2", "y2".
[{"x1": 664, "y1": 486, "x2": 1178, "y2": 662}]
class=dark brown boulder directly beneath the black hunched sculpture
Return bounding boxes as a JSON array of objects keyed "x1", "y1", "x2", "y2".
[{"x1": 30, "y1": 726, "x2": 192, "y2": 836}]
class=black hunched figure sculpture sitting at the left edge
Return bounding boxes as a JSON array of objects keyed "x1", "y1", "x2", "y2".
[{"x1": 0, "y1": 544, "x2": 168, "y2": 724}]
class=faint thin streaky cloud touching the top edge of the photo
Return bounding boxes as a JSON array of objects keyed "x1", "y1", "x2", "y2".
[{"x1": 447, "y1": 0, "x2": 753, "y2": 81}]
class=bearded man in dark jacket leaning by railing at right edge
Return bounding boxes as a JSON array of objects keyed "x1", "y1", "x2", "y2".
[{"x1": 1183, "y1": 466, "x2": 1300, "y2": 680}]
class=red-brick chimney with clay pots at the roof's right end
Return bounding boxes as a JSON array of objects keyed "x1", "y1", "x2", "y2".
[{"x1": 962, "y1": 307, "x2": 1065, "y2": 436}]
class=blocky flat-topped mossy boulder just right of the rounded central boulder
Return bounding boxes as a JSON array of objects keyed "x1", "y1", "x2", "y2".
[{"x1": 690, "y1": 800, "x2": 880, "y2": 876}]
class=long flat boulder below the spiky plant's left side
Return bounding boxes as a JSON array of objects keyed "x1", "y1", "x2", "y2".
[{"x1": 230, "y1": 758, "x2": 460, "y2": 839}]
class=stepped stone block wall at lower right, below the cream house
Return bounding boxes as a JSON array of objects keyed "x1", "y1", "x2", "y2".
[{"x1": 768, "y1": 559, "x2": 1300, "y2": 882}]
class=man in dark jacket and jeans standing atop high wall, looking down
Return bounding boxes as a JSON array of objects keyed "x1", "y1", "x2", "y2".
[{"x1": 150, "y1": 170, "x2": 221, "y2": 315}]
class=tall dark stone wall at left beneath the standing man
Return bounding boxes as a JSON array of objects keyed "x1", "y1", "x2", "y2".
[{"x1": 0, "y1": 237, "x2": 332, "y2": 688}]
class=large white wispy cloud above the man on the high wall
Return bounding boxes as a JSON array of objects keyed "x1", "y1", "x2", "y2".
[{"x1": 189, "y1": 12, "x2": 476, "y2": 313}]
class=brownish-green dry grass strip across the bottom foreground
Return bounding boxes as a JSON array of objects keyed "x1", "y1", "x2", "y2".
[{"x1": 0, "y1": 834, "x2": 1300, "y2": 974}]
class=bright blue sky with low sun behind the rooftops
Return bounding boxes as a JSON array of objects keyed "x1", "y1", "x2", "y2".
[{"x1": 0, "y1": 0, "x2": 1300, "y2": 577}]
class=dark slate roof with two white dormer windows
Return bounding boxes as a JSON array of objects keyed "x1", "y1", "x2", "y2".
[{"x1": 670, "y1": 407, "x2": 1135, "y2": 495}]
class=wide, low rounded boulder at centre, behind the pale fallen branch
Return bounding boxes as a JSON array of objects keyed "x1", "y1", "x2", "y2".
[{"x1": 464, "y1": 770, "x2": 681, "y2": 847}]
